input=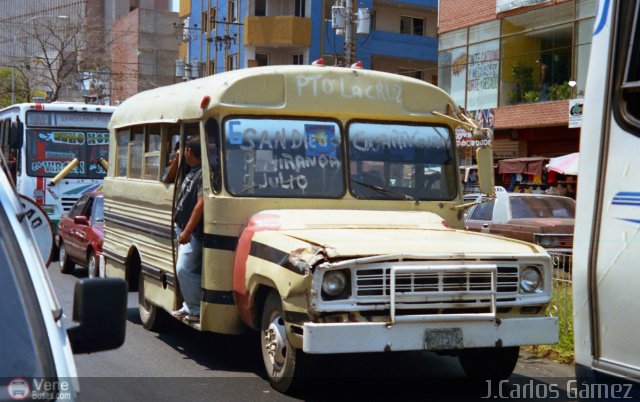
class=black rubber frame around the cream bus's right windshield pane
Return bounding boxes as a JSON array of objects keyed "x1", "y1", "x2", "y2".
[{"x1": 345, "y1": 119, "x2": 462, "y2": 202}]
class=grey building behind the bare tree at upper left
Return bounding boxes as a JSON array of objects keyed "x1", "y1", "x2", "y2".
[{"x1": 0, "y1": 0, "x2": 172, "y2": 103}]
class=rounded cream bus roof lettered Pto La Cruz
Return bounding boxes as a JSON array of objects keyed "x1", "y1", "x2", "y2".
[{"x1": 109, "y1": 65, "x2": 457, "y2": 128}]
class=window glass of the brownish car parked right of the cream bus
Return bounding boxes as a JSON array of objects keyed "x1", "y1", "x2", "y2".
[{"x1": 509, "y1": 197, "x2": 576, "y2": 219}]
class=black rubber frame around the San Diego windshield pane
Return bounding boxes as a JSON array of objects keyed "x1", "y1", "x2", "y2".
[{"x1": 219, "y1": 114, "x2": 349, "y2": 200}]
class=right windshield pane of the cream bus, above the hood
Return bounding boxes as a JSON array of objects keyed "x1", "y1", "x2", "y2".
[{"x1": 348, "y1": 122, "x2": 458, "y2": 200}]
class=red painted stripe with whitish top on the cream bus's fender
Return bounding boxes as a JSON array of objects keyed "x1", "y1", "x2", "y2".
[{"x1": 233, "y1": 212, "x2": 282, "y2": 326}]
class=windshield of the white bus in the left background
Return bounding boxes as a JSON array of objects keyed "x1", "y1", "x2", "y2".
[{"x1": 26, "y1": 128, "x2": 109, "y2": 179}]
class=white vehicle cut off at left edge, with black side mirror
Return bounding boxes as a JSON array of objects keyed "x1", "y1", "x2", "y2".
[{"x1": 0, "y1": 154, "x2": 127, "y2": 401}]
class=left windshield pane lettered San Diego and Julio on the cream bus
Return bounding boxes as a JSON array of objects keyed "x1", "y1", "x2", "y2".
[{"x1": 224, "y1": 118, "x2": 345, "y2": 198}]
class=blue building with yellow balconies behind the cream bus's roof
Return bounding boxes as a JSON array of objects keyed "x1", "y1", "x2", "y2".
[{"x1": 180, "y1": 0, "x2": 438, "y2": 83}]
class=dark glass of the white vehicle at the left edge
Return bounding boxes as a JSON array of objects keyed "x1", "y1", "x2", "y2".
[{"x1": 0, "y1": 204, "x2": 56, "y2": 378}]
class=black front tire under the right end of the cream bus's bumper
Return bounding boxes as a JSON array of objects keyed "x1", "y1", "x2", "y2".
[{"x1": 458, "y1": 346, "x2": 520, "y2": 380}]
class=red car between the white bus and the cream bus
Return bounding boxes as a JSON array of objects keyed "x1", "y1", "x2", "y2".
[{"x1": 57, "y1": 193, "x2": 104, "y2": 278}]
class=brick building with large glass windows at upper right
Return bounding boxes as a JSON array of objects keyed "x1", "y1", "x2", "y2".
[{"x1": 438, "y1": 0, "x2": 596, "y2": 162}]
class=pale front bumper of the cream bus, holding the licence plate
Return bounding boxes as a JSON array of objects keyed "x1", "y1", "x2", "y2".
[{"x1": 302, "y1": 317, "x2": 559, "y2": 354}]
